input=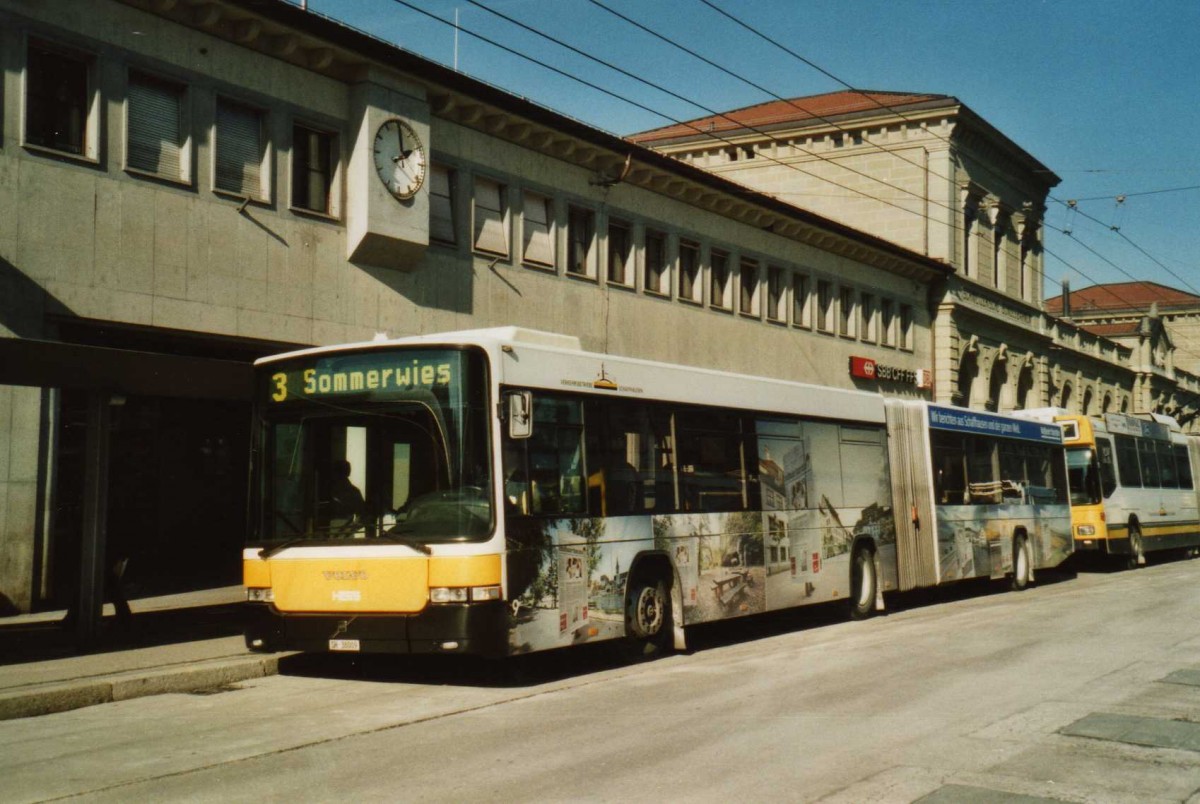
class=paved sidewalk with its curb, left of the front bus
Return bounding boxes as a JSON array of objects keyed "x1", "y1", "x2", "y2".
[{"x1": 0, "y1": 586, "x2": 287, "y2": 720}]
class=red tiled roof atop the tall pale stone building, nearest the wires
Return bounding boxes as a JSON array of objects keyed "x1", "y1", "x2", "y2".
[{"x1": 626, "y1": 90, "x2": 958, "y2": 143}]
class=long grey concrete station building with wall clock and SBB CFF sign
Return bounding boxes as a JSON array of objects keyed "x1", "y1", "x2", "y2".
[{"x1": 0, "y1": 0, "x2": 945, "y2": 613}]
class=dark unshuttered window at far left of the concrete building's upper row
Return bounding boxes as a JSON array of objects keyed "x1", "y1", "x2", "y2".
[{"x1": 25, "y1": 41, "x2": 96, "y2": 158}]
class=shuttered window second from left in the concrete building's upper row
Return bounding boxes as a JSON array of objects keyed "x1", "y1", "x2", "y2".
[{"x1": 125, "y1": 73, "x2": 191, "y2": 181}]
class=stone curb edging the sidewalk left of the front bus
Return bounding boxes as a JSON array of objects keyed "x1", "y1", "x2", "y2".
[{"x1": 0, "y1": 654, "x2": 287, "y2": 721}]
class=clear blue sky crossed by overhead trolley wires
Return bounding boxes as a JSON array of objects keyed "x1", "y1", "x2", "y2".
[{"x1": 308, "y1": 0, "x2": 1200, "y2": 302}]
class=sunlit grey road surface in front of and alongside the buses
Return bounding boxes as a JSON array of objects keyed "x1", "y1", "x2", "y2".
[{"x1": 0, "y1": 560, "x2": 1200, "y2": 804}]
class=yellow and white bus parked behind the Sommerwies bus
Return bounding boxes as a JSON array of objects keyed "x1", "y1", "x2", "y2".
[{"x1": 1025, "y1": 408, "x2": 1200, "y2": 569}]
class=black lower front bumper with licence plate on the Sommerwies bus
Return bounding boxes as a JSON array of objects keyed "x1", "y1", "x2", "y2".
[{"x1": 246, "y1": 600, "x2": 509, "y2": 658}]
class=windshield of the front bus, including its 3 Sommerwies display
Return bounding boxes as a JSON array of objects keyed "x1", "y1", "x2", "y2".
[{"x1": 252, "y1": 348, "x2": 494, "y2": 547}]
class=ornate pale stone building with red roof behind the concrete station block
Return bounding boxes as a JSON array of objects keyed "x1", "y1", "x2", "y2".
[{"x1": 629, "y1": 90, "x2": 1200, "y2": 427}]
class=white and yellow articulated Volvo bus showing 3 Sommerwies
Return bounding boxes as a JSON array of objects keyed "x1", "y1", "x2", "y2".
[{"x1": 244, "y1": 328, "x2": 1072, "y2": 656}]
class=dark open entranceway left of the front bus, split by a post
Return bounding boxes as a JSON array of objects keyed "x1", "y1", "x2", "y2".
[{"x1": 44, "y1": 390, "x2": 250, "y2": 606}]
